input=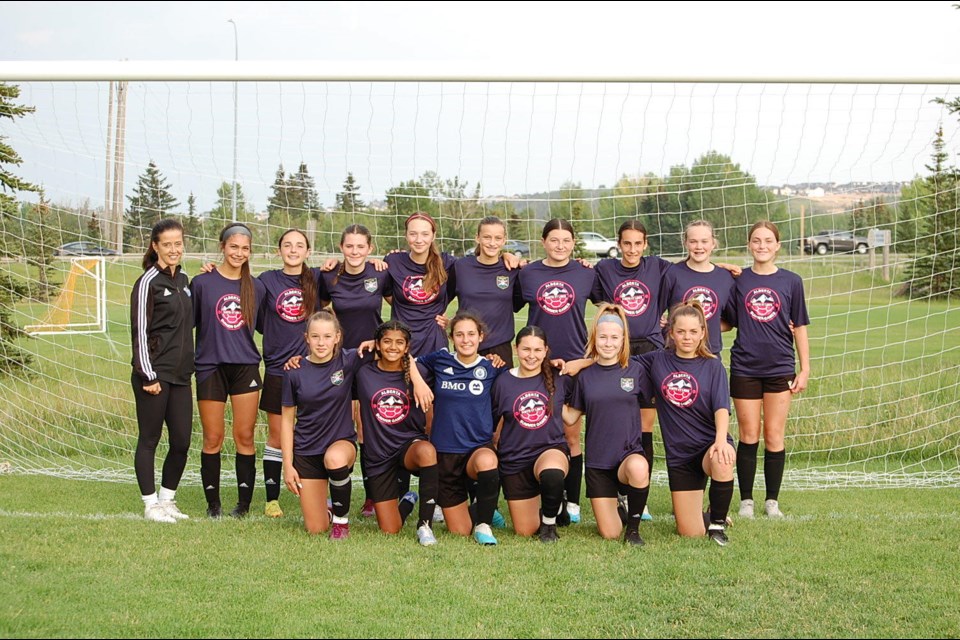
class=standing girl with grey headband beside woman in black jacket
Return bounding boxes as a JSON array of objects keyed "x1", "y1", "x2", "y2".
[{"x1": 190, "y1": 223, "x2": 264, "y2": 518}]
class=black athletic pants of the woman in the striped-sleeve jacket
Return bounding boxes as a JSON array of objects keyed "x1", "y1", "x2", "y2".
[{"x1": 132, "y1": 375, "x2": 193, "y2": 496}]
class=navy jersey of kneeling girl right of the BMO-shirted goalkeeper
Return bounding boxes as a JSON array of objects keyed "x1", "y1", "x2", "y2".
[{"x1": 493, "y1": 371, "x2": 573, "y2": 474}]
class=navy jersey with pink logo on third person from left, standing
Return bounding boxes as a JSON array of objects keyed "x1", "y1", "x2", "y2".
[{"x1": 257, "y1": 269, "x2": 323, "y2": 376}]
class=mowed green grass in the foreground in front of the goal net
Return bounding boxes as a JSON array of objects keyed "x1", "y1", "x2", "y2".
[{"x1": 0, "y1": 475, "x2": 960, "y2": 638}]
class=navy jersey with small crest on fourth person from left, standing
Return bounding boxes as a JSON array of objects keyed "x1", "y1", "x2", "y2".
[{"x1": 323, "y1": 263, "x2": 392, "y2": 349}]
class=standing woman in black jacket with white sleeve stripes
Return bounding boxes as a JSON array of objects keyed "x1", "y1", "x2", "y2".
[{"x1": 130, "y1": 218, "x2": 194, "y2": 523}]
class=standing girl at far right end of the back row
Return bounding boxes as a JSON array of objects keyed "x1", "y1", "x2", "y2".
[{"x1": 730, "y1": 220, "x2": 810, "y2": 518}]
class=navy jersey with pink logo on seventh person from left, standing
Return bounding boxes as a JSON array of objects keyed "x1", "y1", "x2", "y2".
[{"x1": 520, "y1": 260, "x2": 596, "y2": 360}]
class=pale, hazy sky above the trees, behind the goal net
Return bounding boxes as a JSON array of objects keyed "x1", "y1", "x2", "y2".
[{"x1": 0, "y1": 2, "x2": 960, "y2": 209}]
